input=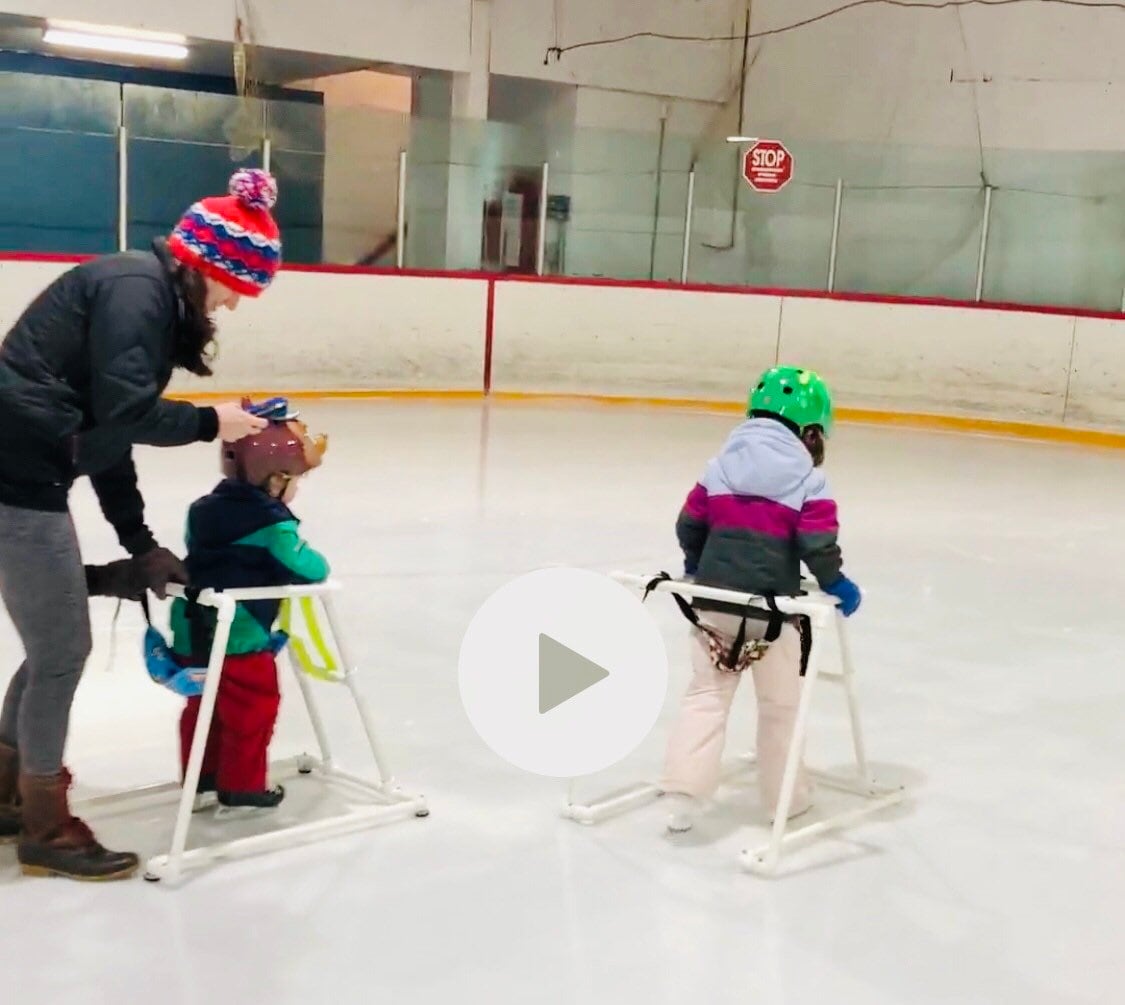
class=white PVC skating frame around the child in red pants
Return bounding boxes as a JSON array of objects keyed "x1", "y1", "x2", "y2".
[{"x1": 75, "y1": 582, "x2": 430, "y2": 882}]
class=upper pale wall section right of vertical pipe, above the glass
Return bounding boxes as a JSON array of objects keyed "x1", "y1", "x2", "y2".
[{"x1": 746, "y1": 0, "x2": 1125, "y2": 151}]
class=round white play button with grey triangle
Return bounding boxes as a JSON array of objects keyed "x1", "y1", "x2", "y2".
[{"x1": 458, "y1": 568, "x2": 668, "y2": 778}]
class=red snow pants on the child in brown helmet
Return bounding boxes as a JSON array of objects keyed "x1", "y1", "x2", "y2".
[{"x1": 180, "y1": 652, "x2": 281, "y2": 792}]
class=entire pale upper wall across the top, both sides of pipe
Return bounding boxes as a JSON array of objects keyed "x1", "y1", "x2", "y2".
[{"x1": 10, "y1": 0, "x2": 1125, "y2": 151}]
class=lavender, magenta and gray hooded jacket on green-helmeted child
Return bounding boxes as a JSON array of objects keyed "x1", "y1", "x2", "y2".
[{"x1": 676, "y1": 419, "x2": 843, "y2": 608}]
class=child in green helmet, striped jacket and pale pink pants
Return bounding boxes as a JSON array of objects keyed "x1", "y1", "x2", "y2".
[{"x1": 662, "y1": 367, "x2": 861, "y2": 832}]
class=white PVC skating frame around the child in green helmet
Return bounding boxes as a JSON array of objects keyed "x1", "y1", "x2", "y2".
[{"x1": 563, "y1": 573, "x2": 906, "y2": 876}]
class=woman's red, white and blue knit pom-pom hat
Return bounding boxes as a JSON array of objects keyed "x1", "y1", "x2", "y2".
[{"x1": 168, "y1": 168, "x2": 281, "y2": 297}]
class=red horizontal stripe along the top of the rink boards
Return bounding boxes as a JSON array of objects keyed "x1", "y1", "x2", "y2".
[{"x1": 0, "y1": 251, "x2": 1125, "y2": 321}]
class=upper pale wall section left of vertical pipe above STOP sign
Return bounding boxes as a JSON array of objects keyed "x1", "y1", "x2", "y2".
[{"x1": 0, "y1": 0, "x2": 741, "y2": 101}]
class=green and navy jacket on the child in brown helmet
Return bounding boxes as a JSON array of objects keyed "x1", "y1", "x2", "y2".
[{"x1": 172, "y1": 479, "x2": 329, "y2": 664}]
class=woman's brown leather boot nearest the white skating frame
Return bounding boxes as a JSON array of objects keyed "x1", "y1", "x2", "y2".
[{"x1": 17, "y1": 772, "x2": 140, "y2": 880}]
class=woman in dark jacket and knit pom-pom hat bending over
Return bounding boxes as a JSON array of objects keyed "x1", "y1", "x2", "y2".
[{"x1": 0, "y1": 170, "x2": 281, "y2": 879}]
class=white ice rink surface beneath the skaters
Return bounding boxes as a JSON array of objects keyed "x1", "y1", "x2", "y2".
[{"x1": 0, "y1": 401, "x2": 1125, "y2": 1005}]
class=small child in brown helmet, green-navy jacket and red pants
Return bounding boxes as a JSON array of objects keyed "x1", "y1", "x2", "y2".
[{"x1": 171, "y1": 400, "x2": 329, "y2": 808}]
